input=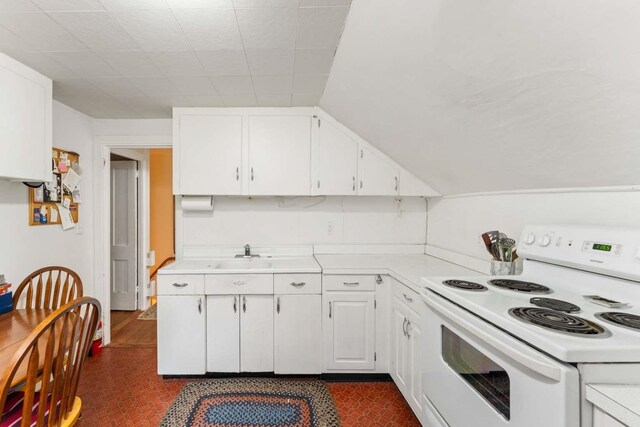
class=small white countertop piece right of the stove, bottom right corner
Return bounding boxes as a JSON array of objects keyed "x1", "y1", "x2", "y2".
[{"x1": 586, "y1": 384, "x2": 640, "y2": 426}]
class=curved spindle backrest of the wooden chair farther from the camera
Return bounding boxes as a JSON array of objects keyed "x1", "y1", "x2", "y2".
[{"x1": 13, "y1": 266, "x2": 82, "y2": 309}]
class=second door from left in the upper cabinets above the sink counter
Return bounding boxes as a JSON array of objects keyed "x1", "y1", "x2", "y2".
[{"x1": 249, "y1": 116, "x2": 311, "y2": 196}]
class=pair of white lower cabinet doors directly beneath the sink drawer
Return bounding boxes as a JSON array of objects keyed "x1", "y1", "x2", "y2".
[{"x1": 206, "y1": 295, "x2": 273, "y2": 372}]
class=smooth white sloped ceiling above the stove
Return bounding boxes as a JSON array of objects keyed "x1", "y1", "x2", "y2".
[{"x1": 320, "y1": 0, "x2": 640, "y2": 194}]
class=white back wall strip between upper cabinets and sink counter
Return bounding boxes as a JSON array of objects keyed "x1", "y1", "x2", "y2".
[{"x1": 178, "y1": 197, "x2": 426, "y2": 251}]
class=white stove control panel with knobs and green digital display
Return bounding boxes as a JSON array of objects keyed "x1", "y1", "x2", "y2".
[{"x1": 518, "y1": 225, "x2": 640, "y2": 282}]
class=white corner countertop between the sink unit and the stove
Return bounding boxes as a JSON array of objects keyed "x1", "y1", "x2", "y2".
[{"x1": 315, "y1": 254, "x2": 479, "y2": 292}]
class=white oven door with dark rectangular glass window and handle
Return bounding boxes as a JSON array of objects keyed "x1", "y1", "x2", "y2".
[{"x1": 422, "y1": 289, "x2": 580, "y2": 427}]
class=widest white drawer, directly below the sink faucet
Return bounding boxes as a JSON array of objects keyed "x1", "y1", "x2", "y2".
[{"x1": 204, "y1": 274, "x2": 273, "y2": 295}]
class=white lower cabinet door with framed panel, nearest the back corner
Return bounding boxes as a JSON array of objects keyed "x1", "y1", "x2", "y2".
[{"x1": 322, "y1": 292, "x2": 375, "y2": 370}]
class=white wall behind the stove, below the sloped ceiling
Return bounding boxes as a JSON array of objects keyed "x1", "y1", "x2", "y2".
[{"x1": 427, "y1": 191, "x2": 640, "y2": 260}]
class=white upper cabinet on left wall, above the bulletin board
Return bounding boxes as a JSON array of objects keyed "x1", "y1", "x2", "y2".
[{"x1": 0, "y1": 53, "x2": 52, "y2": 181}]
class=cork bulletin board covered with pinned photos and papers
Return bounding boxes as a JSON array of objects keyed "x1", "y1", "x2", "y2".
[{"x1": 29, "y1": 148, "x2": 81, "y2": 230}]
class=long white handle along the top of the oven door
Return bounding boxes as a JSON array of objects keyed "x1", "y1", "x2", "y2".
[{"x1": 421, "y1": 292, "x2": 562, "y2": 381}]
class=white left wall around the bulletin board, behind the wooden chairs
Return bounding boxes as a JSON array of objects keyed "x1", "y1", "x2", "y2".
[{"x1": 0, "y1": 101, "x2": 94, "y2": 295}]
